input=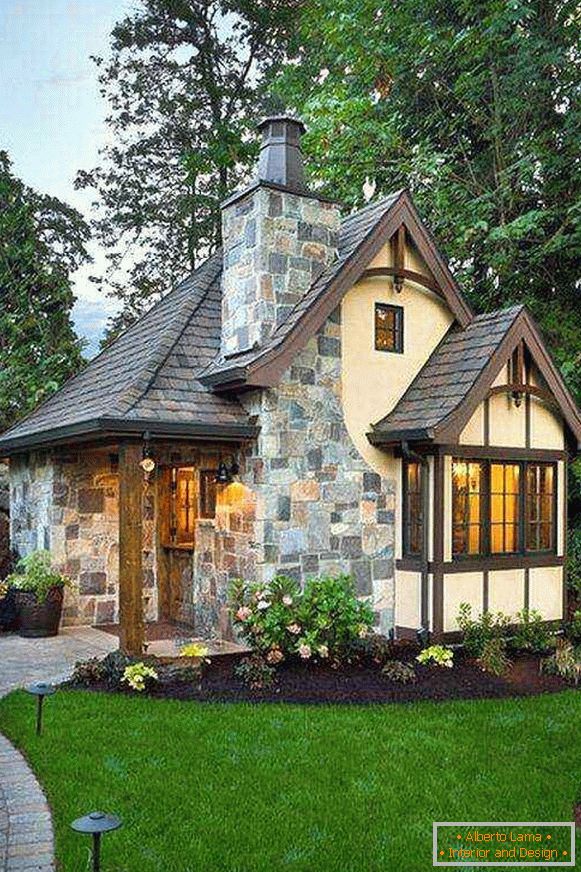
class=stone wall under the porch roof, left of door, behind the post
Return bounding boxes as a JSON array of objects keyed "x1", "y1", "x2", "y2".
[{"x1": 10, "y1": 449, "x2": 157, "y2": 624}]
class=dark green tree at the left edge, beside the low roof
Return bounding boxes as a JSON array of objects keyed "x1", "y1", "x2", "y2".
[{"x1": 0, "y1": 151, "x2": 89, "y2": 432}]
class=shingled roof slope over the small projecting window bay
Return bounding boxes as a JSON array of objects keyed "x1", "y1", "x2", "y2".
[{"x1": 370, "y1": 306, "x2": 524, "y2": 442}]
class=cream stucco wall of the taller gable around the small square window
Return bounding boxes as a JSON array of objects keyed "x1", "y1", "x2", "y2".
[{"x1": 341, "y1": 238, "x2": 453, "y2": 475}]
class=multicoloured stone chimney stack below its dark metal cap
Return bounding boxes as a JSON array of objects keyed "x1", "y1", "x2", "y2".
[{"x1": 222, "y1": 185, "x2": 340, "y2": 355}]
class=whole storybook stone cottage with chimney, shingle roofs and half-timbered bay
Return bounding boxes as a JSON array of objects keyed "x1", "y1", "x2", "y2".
[{"x1": 0, "y1": 117, "x2": 581, "y2": 651}]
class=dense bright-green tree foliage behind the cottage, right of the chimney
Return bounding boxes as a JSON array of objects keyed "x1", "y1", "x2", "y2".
[{"x1": 275, "y1": 0, "x2": 581, "y2": 397}]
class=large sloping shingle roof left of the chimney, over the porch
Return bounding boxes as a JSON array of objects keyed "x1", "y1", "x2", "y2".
[{"x1": 0, "y1": 252, "x2": 255, "y2": 453}]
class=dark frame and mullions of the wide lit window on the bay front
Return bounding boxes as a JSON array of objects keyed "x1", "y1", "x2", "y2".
[{"x1": 450, "y1": 457, "x2": 559, "y2": 562}]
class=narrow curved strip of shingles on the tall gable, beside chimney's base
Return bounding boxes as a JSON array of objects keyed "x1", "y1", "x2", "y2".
[{"x1": 201, "y1": 191, "x2": 402, "y2": 384}]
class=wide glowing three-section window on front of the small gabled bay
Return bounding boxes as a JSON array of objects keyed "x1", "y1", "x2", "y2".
[{"x1": 452, "y1": 459, "x2": 556, "y2": 557}]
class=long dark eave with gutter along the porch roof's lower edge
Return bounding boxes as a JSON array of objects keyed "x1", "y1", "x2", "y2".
[{"x1": 0, "y1": 418, "x2": 259, "y2": 457}]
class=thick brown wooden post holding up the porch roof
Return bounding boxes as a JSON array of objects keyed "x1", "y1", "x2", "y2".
[{"x1": 119, "y1": 442, "x2": 145, "y2": 656}]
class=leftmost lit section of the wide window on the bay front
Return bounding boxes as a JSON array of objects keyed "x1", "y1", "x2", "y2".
[{"x1": 452, "y1": 460, "x2": 484, "y2": 556}]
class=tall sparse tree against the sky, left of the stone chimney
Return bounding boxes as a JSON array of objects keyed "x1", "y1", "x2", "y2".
[{"x1": 77, "y1": 0, "x2": 299, "y2": 336}]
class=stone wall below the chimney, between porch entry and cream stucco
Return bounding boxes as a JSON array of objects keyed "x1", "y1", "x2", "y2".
[{"x1": 242, "y1": 309, "x2": 395, "y2": 632}]
